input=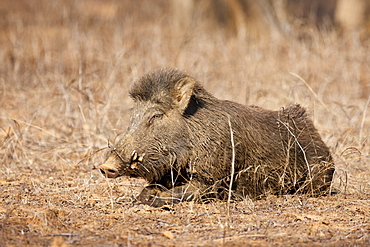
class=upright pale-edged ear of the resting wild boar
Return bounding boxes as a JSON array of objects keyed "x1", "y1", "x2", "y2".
[{"x1": 174, "y1": 77, "x2": 195, "y2": 112}]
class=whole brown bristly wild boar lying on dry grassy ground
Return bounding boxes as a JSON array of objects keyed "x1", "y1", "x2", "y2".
[{"x1": 100, "y1": 69, "x2": 334, "y2": 206}]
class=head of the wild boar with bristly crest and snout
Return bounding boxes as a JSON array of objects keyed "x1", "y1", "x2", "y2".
[{"x1": 100, "y1": 69, "x2": 197, "y2": 187}]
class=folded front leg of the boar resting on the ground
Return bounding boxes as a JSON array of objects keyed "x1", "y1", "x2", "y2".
[{"x1": 137, "y1": 183, "x2": 205, "y2": 207}]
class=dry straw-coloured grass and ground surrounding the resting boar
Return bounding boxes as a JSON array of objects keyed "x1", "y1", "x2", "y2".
[{"x1": 0, "y1": 0, "x2": 370, "y2": 246}]
